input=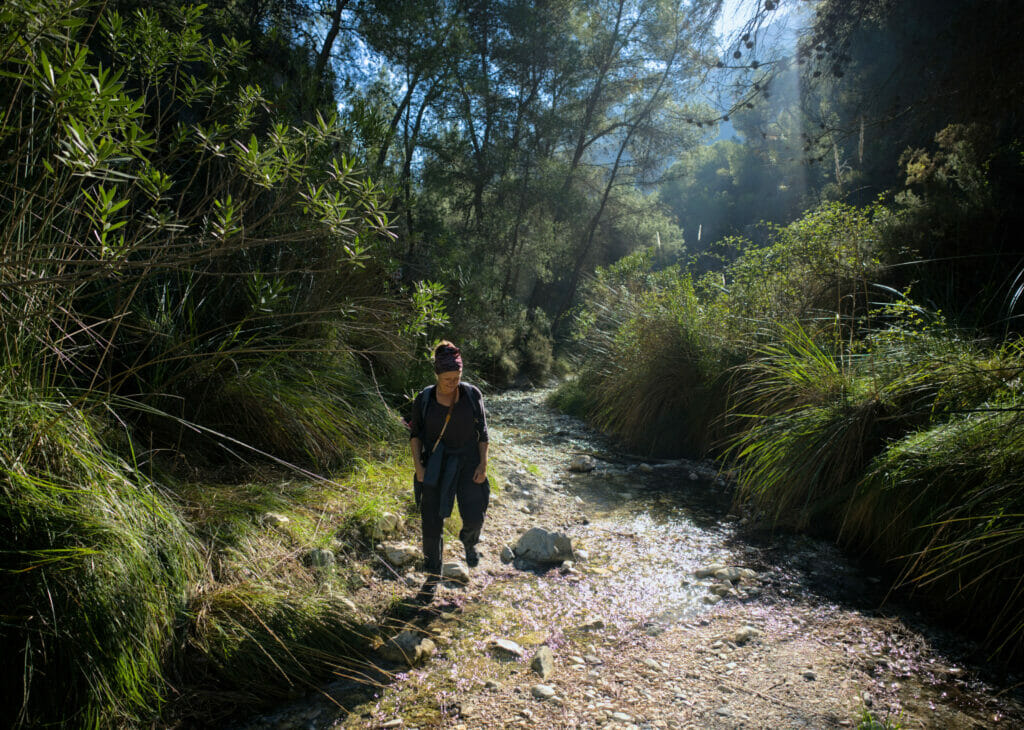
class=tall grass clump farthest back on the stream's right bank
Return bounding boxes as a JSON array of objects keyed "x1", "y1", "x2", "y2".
[{"x1": 552, "y1": 256, "x2": 736, "y2": 455}]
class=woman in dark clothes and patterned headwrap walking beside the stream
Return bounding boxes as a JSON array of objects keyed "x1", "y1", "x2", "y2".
[{"x1": 410, "y1": 340, "x2": 490, "y2": 602}]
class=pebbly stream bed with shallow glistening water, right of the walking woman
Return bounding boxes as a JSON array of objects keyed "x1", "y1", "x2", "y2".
[{"x1": 235, "y1": 393, "x2": 1024, "y2": 729}]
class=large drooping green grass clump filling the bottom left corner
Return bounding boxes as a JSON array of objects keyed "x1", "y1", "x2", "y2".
[{"x1": 0, "y1": 388, "x2": 203, "y2": 728}]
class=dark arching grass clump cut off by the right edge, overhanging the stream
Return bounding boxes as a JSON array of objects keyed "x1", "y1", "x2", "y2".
[{"x1": 843, "y1": 398, "x2": 1024, "y2": 649}]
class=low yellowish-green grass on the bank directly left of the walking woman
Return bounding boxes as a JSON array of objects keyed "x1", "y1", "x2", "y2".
[{"x1": 171, "y1": 443, "x2": 412, "y2": 719}]
